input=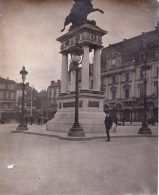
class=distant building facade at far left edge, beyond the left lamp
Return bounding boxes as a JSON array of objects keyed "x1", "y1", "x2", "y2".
[{"x1": 0, "y1": 77, "x2": 16, "y2": 123}]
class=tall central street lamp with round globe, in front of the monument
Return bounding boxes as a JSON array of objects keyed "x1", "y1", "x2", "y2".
[{"x1": 68, "y1": 45, "x2": 85, "y2": 137}]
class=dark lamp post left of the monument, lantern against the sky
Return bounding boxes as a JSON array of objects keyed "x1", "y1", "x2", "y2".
[{"x1": 17, "y1": 66, "x2": 28, "y2": 131}]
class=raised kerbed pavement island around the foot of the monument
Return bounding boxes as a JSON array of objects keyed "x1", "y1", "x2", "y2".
[{"x1": 12, "y1": 123, "x2": 158, "y2": 140}]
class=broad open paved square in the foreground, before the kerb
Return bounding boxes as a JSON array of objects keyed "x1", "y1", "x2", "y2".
[{"x1": 0, "y1": 125, "x2": 158, "y2": 195}]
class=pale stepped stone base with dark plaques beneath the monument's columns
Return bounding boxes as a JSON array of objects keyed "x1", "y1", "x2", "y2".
[{"x1": 46, "y1": 93, "x2": 105, "y2": 133}]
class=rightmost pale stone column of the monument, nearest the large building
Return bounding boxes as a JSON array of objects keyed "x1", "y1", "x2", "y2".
[{"x1": 93, "y1": 48, "x2": 100, "y2": 92}]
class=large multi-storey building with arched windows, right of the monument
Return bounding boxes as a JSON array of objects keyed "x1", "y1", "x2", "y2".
[{"x1": 101, "y1": 24, "x2": 159, "y2": 122}]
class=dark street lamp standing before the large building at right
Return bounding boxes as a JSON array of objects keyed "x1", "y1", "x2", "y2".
[{"x1": 138, "y1": 61, "x2": 152, "y2": 134}]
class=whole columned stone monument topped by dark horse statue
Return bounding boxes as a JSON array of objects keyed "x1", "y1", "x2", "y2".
[{"x1": 46, "y1": 0, "x2": 107, "y2": 133}]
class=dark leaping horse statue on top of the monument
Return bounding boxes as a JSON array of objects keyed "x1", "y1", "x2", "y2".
[{"x1": 61, "y1": 0, "x2": 104, "y2": 32}]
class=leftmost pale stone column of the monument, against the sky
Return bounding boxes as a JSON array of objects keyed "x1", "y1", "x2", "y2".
[{"x1": 61, "y1": 53, "x2": 68, "y2": 94}]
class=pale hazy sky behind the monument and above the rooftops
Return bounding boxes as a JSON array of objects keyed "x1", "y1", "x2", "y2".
[{"x1": 0, "y1": 0, "x2": 159, "y2": 91}]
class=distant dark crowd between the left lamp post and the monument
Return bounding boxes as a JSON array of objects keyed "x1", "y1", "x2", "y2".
[{"x1": 25, "y1": 115, "x2": 48, "y2": 125}]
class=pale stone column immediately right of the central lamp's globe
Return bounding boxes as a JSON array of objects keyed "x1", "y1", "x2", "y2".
[{"x1": 81, "y1": 45, "x2": 89, "y2": 91}]
